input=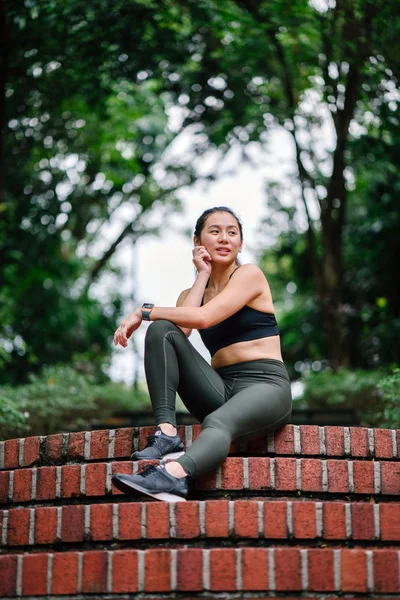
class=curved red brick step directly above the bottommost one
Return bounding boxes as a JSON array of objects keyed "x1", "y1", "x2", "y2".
[{"x1": 0, "y1": 500, "x2": 400, "y2": 549}]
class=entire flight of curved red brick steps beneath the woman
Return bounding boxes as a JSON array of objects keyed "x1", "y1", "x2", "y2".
[{"x1": 0, "y1": 425, "x2": 400, "y2": 600}]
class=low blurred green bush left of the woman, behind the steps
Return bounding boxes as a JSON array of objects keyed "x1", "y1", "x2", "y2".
[{"x1": 0, "y1": 365, "x2": 150, "y2": 439}]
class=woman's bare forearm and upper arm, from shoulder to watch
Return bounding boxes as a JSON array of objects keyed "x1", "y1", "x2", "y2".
[{"x1": 150, "y1": 264, "x2": 266, "y2": 329}]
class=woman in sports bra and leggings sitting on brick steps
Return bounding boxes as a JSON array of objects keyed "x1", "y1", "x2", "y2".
[{"x1": 113, "y1": 207, "x2": 292, "y2": 501}]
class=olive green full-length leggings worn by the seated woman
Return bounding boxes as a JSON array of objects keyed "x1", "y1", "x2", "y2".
[{"x1": 145, "y1": 320, "x2": 292, "y2": 477}]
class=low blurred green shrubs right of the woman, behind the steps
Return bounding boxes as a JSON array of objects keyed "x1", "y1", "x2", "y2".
[{"x1": 296, "y1": 369, "x2": 400, "y2": 428}]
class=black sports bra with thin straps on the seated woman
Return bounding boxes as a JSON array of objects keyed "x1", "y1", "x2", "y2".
[{"x1": 199, "y1": 267, "x2": 279, "y2": 356}]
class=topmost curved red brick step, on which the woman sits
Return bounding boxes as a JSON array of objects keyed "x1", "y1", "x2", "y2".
[{"x1": 0, "y1": 425, "x2": 400, "y2": 470}]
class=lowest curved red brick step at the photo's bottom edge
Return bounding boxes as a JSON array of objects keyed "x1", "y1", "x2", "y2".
[{"x1": 0, "y1": 547, "x2": 400, "y2": 598}]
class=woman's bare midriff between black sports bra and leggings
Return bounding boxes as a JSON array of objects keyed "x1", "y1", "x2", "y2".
[{"x1": 211, "y1": 335, "x2": 282, "y2": 369}]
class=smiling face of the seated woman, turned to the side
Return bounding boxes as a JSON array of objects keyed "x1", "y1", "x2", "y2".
[{"x1": 195, "y1": 212, "x2": 242, "y2": 263}]
